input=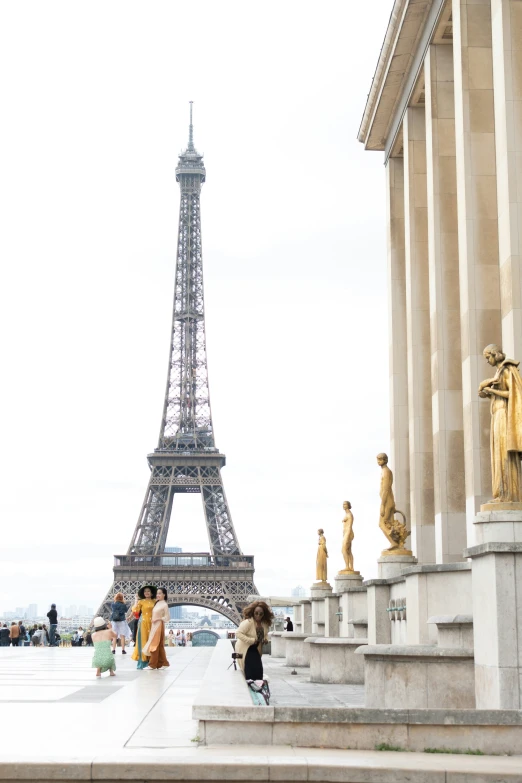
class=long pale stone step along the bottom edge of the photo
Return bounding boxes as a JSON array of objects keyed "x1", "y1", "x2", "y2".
[{"x1": 0, "y1": 747, "x2": 522, "y2": 783}]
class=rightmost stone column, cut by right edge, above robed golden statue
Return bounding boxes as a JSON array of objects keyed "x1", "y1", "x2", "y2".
[{"x1": 491, "y1": 0, "x2": 522, "y2": 358}]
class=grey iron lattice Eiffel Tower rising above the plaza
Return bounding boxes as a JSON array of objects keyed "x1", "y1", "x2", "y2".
[{"x1": 98, "y1": 101, "x2": 258, "y2": 624}]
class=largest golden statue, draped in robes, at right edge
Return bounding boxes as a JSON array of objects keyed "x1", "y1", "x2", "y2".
[{"x1": 479, "y1": 345, "x2": 522, "y2": 508}]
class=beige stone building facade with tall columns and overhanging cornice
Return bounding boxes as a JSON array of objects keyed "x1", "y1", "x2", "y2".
[{"x1": 359, "y1": 0, "x2": 522, "y2": 564}]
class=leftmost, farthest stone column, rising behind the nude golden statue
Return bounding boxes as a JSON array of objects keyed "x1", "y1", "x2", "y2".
[{"x1": 386, "y1": 158, "x2": 410, "y2": 524}]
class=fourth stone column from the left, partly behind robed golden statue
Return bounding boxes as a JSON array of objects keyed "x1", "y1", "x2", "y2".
[{"x1": 452, "y1": 0, "x2": 501, "y2": 546}]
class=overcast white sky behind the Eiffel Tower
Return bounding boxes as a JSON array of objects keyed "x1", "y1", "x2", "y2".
[{"x1": 0, "y1": 0, "x2": 393, "y2": 612}]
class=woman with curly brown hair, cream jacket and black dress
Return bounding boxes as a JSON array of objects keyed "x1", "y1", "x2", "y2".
[{"x1": 235, "y1": 601, "x2": 274, "y2": 680}]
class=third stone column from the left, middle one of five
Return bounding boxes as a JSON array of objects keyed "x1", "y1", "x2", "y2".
[{"x1": 424, "y1": 45, "x2": 466, "y2": 563}]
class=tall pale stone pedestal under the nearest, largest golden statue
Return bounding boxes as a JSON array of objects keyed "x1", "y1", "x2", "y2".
[{"x1": 464, "y1": 504, "x2": 522, "y2": 710}]
